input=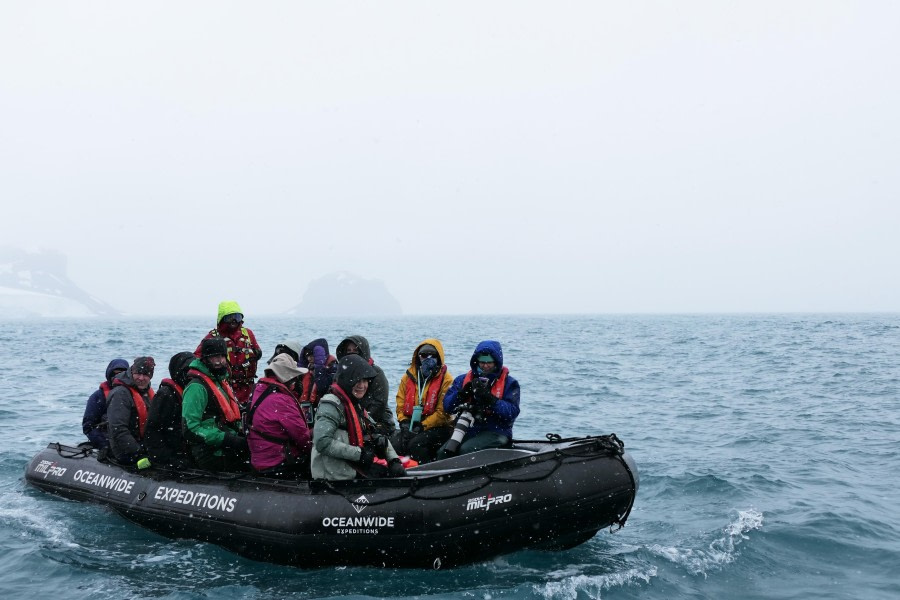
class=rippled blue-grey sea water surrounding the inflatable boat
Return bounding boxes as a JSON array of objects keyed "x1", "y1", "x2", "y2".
[{"x1": 0, "y1": 314, "x2": 900, "y2": 600}]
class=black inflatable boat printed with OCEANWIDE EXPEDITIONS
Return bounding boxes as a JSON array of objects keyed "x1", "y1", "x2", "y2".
[{"x1": 25, "y1": 435, "x2": 638, "y2": 568}]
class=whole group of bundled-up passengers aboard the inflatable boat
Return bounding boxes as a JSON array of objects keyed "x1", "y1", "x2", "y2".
[{"x1": 82, "y1": 301, "x2": 519, "y2": 480}]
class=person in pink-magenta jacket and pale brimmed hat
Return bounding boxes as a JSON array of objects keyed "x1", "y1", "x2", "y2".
[{"x1": 246, "y1": 354, "x2": 312, "y2": 478}]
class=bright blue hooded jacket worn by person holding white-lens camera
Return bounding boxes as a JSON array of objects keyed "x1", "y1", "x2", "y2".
[{"x1": 444, "y1": 340, "x2": 519, "y2": 439}]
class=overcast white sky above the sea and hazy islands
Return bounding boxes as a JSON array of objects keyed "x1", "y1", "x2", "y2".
[{"x1": 0, "y1": 0, "x2": 900, "y2": 315}]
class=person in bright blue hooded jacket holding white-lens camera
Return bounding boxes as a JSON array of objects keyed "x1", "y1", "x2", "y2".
[{"x1": 438, "y1": 340, "x2": 519, "y2": 459}]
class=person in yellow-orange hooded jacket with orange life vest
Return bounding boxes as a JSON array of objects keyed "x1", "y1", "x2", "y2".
[{"x1": 391, "y1": 338, "x2": 453, "y2": 464}]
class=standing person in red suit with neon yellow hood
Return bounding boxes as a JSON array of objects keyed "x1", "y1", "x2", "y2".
[{"x1": 194, "y1": 300, "x2": 262, "y2": 406}]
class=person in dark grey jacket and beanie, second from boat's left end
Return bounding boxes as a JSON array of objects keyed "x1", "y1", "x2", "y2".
[{"x1": 106, "y1": 356, "x2": 156, "y2": 469}]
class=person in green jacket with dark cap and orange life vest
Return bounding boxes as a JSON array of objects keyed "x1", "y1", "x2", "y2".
[{"x1": 181, "y1": 338, "x2": 250, "y2": 471}]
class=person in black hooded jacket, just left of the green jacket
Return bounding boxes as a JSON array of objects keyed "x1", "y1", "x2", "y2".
[{"x1": 144, "y1": 352, "x2": 194, "y2": 468}]
